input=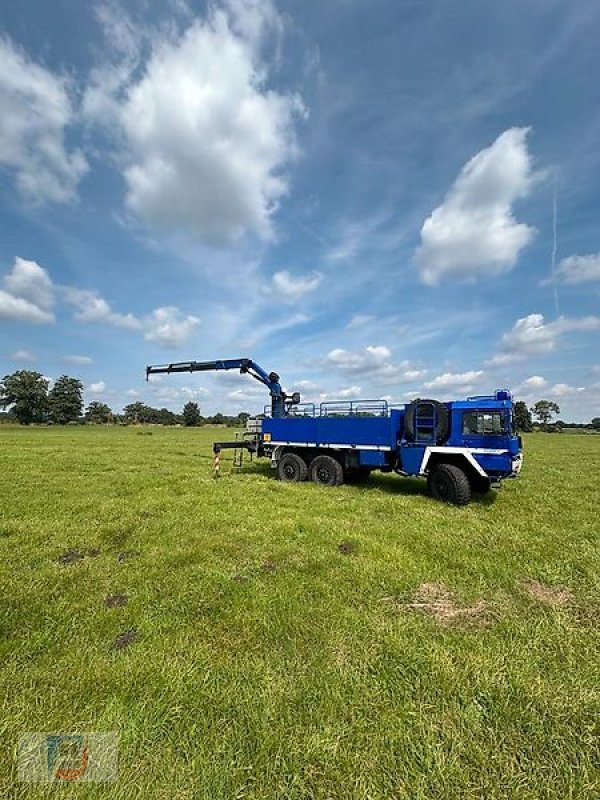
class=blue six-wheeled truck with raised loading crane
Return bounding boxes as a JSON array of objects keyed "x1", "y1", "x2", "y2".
[{"x1": 146, "y1": 358, "x2": 523, "y2": 505}]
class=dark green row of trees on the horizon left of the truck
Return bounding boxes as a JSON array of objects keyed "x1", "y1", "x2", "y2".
[{"x1": 0, "y1": 370, "x2": 250, "y2": 427}]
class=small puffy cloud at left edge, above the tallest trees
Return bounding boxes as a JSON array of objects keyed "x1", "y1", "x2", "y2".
[{"x1": 0, "y1": 256, "x2": 54, "y2": 325}]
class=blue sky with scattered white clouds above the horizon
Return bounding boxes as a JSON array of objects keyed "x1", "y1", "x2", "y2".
[{"x1": 0, "y1": 0, "x2": 600, "y2": 421}]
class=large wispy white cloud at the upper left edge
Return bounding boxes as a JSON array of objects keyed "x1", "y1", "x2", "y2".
[{"x1": 0, "y1": 38, "x2": 87, "y2": 203}]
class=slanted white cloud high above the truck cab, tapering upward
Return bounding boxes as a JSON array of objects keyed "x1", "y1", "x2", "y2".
[{"x1": 415, "y1": 128, "x2": 535, "y2": 286}]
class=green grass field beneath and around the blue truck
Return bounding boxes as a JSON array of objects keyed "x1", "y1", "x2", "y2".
[{"x1": 0, "y1": 427, "x2": 600, "y2": 800}]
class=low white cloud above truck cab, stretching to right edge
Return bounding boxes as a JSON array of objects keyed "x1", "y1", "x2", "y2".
[{"x1": 490, "y1": 314, "x2": 600, "y2": 365}]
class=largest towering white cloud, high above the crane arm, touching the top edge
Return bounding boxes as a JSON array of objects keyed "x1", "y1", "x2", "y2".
[{"x1": 116, "y1": 2, "x2": 304, "y2": 244}]
